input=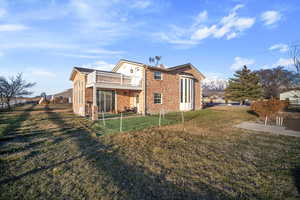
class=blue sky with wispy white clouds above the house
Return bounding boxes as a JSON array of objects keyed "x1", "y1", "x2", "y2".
[{"x1": 0, "y1": 0, "x2": 300, "y2": 95}]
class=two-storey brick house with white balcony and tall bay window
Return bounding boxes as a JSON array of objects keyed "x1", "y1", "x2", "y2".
[{"x1": 70, "y1": 59, "x2": 205, "y2": 119}]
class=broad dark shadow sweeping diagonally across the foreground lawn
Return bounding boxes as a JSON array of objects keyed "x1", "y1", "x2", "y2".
[{"x1": 41, "y1": 106, "x2": 233, "y2": 199}]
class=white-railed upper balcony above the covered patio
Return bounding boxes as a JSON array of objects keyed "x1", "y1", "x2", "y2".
[{"x1": 87, "y1": 71, "x2": 142, "y2": 90}]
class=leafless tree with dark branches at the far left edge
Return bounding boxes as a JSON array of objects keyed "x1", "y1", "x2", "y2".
[{"x1": 0, "y1": 73, "x2": 35, "y2": 110}]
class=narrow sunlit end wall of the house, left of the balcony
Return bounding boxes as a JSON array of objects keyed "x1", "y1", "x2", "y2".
[{"x1": 73, "y1": 72, "x2": 86, "y2": 116}]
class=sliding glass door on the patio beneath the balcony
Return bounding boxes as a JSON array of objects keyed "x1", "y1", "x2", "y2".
[{"x1": 97, "y1": 90, "x2": 115, "y2": 112}]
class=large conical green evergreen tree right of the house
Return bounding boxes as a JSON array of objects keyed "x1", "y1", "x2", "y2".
[{"x1": 225, "y1": 65, "x2": 263, "y2": 104}]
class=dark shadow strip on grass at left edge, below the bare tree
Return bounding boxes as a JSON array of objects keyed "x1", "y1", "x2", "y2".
[{"x1": 0, "y1": 104, "x2": 36, "y2": 137}]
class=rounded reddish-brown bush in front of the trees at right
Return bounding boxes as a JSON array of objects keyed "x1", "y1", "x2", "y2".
[{"x1": 251, "y1": 98, "x2": 288, "y2": 118}]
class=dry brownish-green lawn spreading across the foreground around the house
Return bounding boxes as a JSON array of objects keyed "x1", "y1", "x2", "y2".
[{"x1": 0, "y1": 105, "x2": 300, "y2": 200}]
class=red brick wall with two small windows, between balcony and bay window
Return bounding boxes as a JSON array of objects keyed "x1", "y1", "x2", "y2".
[{"x1": 146, "y1": 69, "x2": 180, "y2": 114}]
